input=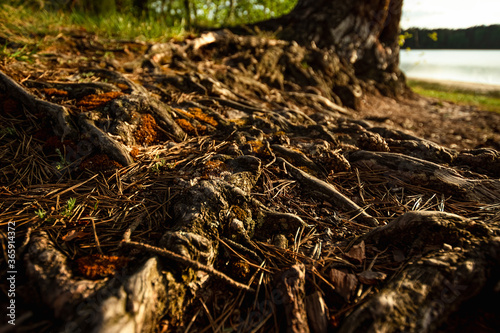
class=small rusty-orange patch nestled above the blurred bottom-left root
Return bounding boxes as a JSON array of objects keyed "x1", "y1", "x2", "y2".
[{"x1": 76, "y1": 254, "x2": 130, "y2": 279}]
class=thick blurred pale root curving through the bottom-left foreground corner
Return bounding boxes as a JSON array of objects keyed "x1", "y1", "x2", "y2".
[{"x1": 26, "y1": 233, "x2": 168, "y2": 332}]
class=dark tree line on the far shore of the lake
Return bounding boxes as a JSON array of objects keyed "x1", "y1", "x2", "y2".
[{"x1": 402, "y1": 24, "x2": 500, "y2": 50}]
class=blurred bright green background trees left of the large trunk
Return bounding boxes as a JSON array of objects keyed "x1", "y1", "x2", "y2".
[{"x1": 0, "y1": 0, "x2": 297, "y2": 27}]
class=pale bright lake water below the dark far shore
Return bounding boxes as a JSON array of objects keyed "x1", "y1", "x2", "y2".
[{"x1": 400, "y1": 50, "x2": 500, "y2": 85}]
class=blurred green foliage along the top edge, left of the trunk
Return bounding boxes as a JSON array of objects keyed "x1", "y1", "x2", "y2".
[{"x1": 0, "y1": 0, "x2": 297, "y2": 32}]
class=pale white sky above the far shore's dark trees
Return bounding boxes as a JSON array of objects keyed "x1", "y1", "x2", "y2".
[{"x1": 401, "y1": 0, "x2": 500, "y2": 29}]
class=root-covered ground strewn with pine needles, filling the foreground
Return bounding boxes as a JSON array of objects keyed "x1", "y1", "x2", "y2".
[{"x1": 0, "y1": 31, "x2": 500, "y2": 332}]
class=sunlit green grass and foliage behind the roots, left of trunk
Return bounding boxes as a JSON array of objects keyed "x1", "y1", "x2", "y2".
[{"x1": 0, "y1": 0, "x2": 297, "y2": 59}]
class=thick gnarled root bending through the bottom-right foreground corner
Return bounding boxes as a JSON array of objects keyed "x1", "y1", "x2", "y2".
[{"x1": 341, "y1": 212, "x2": 500, "y2": 332}]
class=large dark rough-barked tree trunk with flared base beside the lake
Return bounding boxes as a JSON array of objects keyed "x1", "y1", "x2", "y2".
[{"x1": 257, "y1": 0, "x2": 405, "y2": 95}]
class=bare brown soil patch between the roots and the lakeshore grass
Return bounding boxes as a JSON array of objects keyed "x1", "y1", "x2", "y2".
[{"x1": 352, "y1": 95, "x2": 500, "y2": 150}]
